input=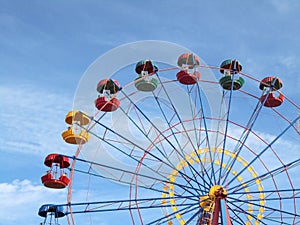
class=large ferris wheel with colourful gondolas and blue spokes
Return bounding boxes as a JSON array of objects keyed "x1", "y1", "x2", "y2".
[{"x1": 38, "y1": 41, "x2": 300, "y2": 225}]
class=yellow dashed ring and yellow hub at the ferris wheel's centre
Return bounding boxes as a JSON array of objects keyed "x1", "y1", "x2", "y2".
[{"x1": 161, "y1": 148, "x2": 265, "y2": 225}]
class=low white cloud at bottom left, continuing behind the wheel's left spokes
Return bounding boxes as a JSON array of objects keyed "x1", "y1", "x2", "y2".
[{"x1": 0, "y1": 179, "x2": 127, "y2": 225}]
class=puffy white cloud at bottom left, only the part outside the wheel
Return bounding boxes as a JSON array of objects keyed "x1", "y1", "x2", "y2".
[{"x1": 0, "y1": 180, "x2": 66, "y2": 225}]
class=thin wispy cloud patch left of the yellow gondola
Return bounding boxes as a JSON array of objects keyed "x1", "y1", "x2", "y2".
[{"x1": 0, "y1": 84, "x2": 71, "y2": 154}]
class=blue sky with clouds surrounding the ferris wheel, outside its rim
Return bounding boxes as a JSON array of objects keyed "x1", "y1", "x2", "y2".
[{"x1": 0, "y1": 0, "x2": 300, "y2": 225}]
